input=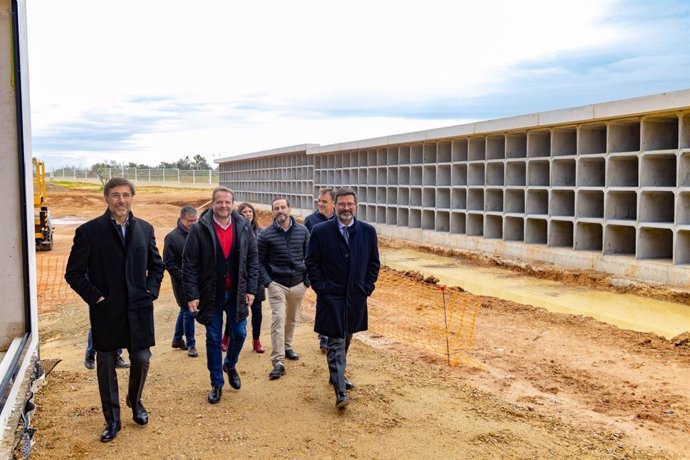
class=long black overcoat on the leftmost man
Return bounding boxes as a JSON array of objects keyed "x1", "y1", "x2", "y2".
[{"x1": 65, "y1": 210, "x2": 165, "y2": 351}]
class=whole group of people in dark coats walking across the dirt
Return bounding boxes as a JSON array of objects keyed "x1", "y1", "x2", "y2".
[{"x1": 65, "y1": 178, "x2": 379, "y2": 442}]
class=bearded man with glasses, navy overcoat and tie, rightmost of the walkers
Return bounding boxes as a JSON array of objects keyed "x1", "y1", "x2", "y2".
[{"x1": 306, "y1": 187, "x2": 381, "y2": 409}]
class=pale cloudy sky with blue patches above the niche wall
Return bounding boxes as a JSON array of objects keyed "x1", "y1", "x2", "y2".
[{"x1": 27, "y1": 0, "x2": 690, "y2": 169}]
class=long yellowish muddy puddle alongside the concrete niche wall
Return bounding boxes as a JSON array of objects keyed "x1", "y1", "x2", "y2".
[{"x1": 379, "y1": 247, "x2": 690, "y2": 338}]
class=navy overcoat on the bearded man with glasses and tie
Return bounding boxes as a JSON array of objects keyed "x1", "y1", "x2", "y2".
[{"x1": 306, "y1": 219, "x2": 381, "y2": 338}]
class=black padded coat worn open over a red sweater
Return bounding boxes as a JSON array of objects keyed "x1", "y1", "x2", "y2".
[{"x1": 182, "y1": 208, "x2": 259, "y2": 325}]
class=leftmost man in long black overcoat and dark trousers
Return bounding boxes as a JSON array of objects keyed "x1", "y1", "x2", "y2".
[{"x1": 65, "y1": 177, "x2": 165, "y2": 442}]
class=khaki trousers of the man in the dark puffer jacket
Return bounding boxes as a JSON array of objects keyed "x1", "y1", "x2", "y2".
[{"x1": 267, "y1": 281, "x2": 307, "y2": 365}]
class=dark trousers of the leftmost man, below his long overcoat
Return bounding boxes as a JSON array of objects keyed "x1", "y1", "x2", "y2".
[{"x1": 96, "y1": 348, "x2": 151, "y2": 424}]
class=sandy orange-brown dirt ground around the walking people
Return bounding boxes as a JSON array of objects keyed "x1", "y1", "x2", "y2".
[{"x1": 26, "y1": 187, "x2": 690, "y2": 459}]
